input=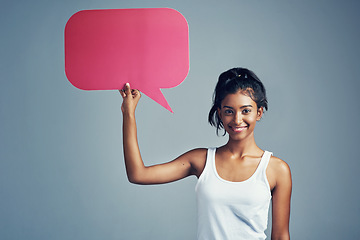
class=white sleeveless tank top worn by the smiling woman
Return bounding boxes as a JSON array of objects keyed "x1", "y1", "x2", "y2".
[{"x1": 195, "y1": 148, "x2": 272, "y2": 240}]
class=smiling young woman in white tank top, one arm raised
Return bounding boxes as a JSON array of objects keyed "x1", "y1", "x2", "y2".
[{"x1": 120, "y1": 68, "x2": 292, "y2": 240}]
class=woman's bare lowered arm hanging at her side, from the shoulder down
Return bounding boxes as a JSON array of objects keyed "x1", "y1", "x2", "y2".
[{"x1": 271, "y1": 157, "x2": 292, "y2": 240}]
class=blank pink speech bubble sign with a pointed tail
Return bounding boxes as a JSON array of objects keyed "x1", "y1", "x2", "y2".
[{"x1": 65, "y1": 8, "x2": 189, "y2": 112}]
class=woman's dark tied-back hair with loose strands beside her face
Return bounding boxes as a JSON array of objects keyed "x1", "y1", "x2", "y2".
[{"x1": 208, "y1": 68, "x2": 268, "y2": 135}]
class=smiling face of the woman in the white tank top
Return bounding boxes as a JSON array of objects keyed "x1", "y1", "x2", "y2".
[{"x1": 218, "y1": 91, "x2": 263, "y2": 140}]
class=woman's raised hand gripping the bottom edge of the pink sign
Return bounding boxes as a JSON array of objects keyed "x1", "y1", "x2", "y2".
[{"x1": 119, "y1": 83, "x2": 141, "y2": 114}]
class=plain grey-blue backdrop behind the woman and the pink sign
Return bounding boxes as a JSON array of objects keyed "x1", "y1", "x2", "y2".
[{"x1": 0, "y1": 0, "x2": 360, "y2": 240}]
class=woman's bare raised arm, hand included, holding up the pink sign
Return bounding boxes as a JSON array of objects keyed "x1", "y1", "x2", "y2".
[{"x1": 120, "y1": 83, "x2": 206, "y2": 184}]
